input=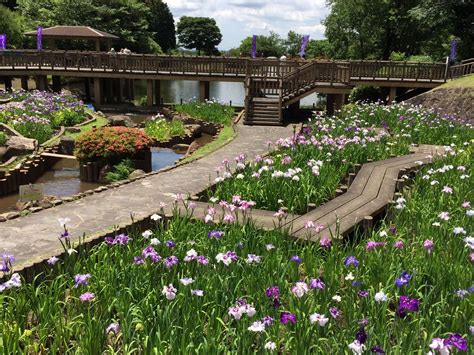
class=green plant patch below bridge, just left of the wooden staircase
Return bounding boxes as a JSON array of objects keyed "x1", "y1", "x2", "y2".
[{"x1": 176, "y1": 100, "x2": 235, "y2": 125}]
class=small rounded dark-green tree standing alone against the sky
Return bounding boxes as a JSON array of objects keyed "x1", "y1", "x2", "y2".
[{"x1": 177, "y1": 16, "x2": 222, "y2": 54}]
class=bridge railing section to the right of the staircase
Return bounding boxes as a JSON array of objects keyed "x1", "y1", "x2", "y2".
[{"x1": 350, "y1": 61, "x2": 446, "y2": 81}]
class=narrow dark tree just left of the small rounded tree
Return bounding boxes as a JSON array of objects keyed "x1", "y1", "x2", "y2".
[{"x1": 145, "y1": 0, "x2": 176, "y2": 52}]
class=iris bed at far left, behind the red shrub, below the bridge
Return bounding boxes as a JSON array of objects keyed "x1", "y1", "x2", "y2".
[{"x1": 0, "y1": 91, "x2": 85, "y2": 143}]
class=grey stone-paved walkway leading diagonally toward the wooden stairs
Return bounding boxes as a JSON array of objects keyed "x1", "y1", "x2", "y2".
[{"x1": 0, "y1": 125, "x2": 293, "y2": 269}]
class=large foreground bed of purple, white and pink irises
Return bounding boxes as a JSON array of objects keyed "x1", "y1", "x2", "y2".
[{"x1": 0, "y1": 144, "x2": 474, "y2": 354}]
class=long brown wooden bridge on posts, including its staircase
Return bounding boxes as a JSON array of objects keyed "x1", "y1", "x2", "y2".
[{"x1": 0, "y1": 50, "x2": 474, "y2": 125}]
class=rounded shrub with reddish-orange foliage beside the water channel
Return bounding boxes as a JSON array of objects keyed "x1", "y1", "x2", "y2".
[{"x1": 74, "y1": 127, "x2": 152, "y2": 162}]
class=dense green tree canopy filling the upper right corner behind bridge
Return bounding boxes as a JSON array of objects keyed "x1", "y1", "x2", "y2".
[{"x1": 324, "y1": 0, "x2": 474, "y2": 60}]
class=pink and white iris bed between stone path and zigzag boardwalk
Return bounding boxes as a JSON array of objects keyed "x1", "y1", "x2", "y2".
[{"x1": 207, "y1": 104, "x2": 472, "y2": 213}]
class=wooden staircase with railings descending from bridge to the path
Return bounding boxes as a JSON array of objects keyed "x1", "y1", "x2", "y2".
[{"x1": 244, "y1": 61, "x2": 350, "y2": 125}]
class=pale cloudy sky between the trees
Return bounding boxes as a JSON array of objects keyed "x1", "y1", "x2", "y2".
[{"x1": 165, "y1": 0, "x2": 329, "y2": 50}]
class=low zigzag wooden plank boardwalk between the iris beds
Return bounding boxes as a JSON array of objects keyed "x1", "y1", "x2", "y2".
[{"x1": 174, "y1": 145, "x2": 444, "y2": 241}]
